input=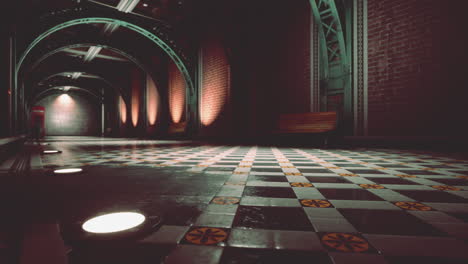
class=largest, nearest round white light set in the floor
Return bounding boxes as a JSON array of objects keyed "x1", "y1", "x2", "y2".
[{"x1": 82, "y1": 212, "x2": 145, "y2": 234}]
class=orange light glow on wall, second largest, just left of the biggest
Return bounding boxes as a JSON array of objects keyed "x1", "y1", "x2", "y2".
[{"x1": 169, "y1": 62, "x2": 185, "y2": 123}]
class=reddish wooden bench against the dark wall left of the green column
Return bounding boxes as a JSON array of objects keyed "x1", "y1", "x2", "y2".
[{"x1": 273, "y1": 112, "x2": 337, "y2": 146}]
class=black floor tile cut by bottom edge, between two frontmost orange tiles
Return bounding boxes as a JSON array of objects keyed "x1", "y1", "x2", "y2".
[{"x1": 220, "y1": 247, "x2": 333, "y2": 264}]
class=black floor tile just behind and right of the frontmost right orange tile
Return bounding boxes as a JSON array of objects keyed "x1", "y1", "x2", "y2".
[{"x1": 338, "y1": 209, "x2": 444, "y2": 236}]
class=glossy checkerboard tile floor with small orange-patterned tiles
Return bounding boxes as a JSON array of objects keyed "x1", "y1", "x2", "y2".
[{"x1": 37, "y1": 141, "x2": 468, "y2": 264}]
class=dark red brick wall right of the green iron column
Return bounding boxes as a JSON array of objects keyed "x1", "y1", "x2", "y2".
[{"x1": 368, "y1": 0, "x2": 466, "y2": 136}]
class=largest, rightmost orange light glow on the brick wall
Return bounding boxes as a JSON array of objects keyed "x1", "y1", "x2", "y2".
[{"x1": 200, "y1": 40, "x2": 230, "y2": 126}]
